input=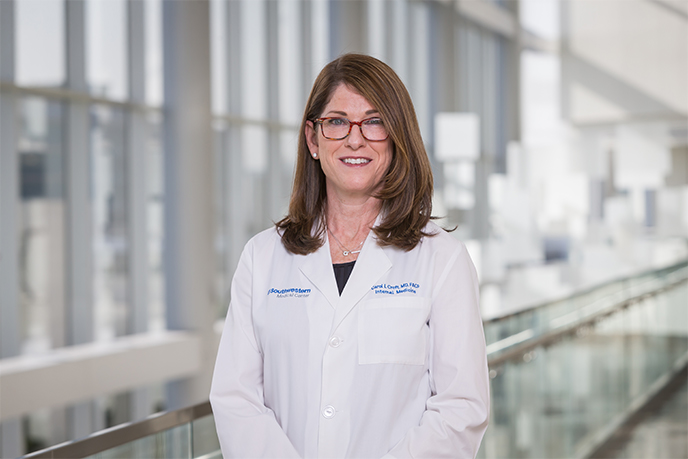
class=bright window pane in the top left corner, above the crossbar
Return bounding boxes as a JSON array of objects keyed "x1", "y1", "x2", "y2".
[{"x1": 14, "y1": 0, "x2": 66, "y2": 87}]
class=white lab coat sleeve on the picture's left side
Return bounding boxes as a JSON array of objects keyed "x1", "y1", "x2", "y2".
[{"x1": 210, "y1": 243, "x2": 300, "y2": 459}]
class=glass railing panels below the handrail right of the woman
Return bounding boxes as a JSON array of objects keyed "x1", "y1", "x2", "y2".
[{"x1": 479, "y1": 276, "x2": 688, "y2": 459}]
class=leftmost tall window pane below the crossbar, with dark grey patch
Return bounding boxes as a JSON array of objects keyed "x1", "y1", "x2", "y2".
[{"x1": 18, "y1": 97, "x2": 66, "y2": 354}]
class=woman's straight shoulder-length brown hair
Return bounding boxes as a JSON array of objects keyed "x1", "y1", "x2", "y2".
[{"x1": 275, "y1": 54, "x2": 433, "y2": 255}]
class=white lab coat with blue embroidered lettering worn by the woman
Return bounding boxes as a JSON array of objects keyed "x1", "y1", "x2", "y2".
[{"x1": 210, "y1": 223, "x2": 489, "y2": 459}]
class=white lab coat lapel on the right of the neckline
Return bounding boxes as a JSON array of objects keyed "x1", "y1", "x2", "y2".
[{"x1": 332, "y1": 231, "x2": 392, "y2": 330}]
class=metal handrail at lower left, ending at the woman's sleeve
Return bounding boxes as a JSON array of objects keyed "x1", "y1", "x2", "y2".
[{"x1": 21, "y1": 401, "x2": 213, "y2": 459}]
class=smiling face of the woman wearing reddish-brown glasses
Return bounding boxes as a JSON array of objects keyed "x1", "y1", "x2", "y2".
[{"x1": 306, "y1": 83, "x2": 392, "y2": 203}]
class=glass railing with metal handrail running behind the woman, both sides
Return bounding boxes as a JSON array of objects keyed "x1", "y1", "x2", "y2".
[{"x1": 25, "y1": 263, "x2": 688, "y2": 459}]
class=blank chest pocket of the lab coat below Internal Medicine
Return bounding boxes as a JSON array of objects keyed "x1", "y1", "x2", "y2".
[{"x1": 358, "y1": 297, "x2": 430, "y2": 365}]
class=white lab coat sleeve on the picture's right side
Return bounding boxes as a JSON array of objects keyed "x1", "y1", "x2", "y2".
[{"x1": 385, "y1": 245, "x2": 490, "y2": 459}]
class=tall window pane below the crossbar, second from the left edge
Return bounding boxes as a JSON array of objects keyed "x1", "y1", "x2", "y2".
[{"x1": 91, "y1": 105, "x2": 128, "y2": 341}]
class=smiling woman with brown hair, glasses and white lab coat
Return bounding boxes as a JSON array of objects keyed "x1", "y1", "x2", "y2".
[{"x1": 210, "y1": 54, "x2": 489, "y2": 458}]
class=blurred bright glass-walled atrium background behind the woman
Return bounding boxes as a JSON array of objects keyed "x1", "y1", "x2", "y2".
[{"x1": 0, "y1": 0, "x2": 688, "y2": 457}]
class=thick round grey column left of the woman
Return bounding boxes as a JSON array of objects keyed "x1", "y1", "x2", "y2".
[{"x1": 163, "y1": 0, "x2": 216, "y2": 409}]
